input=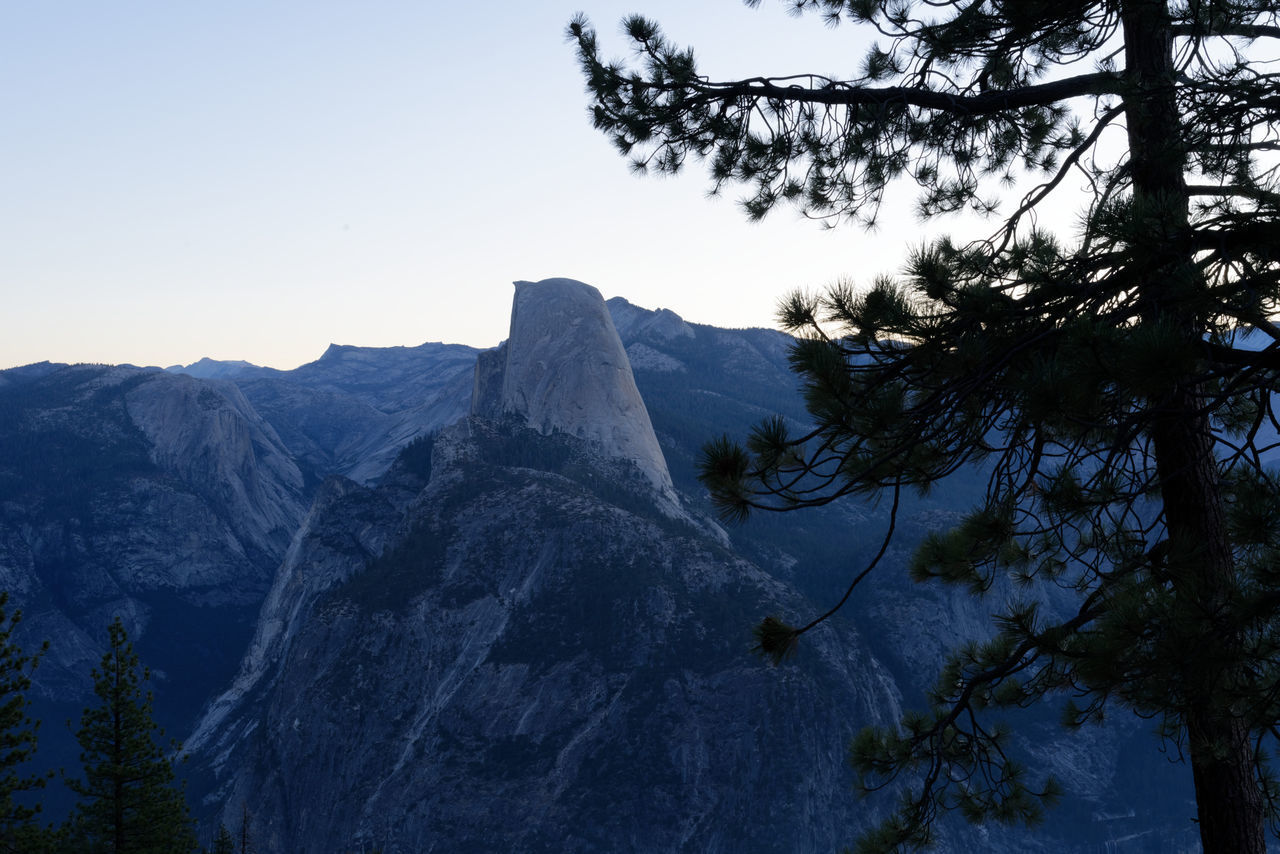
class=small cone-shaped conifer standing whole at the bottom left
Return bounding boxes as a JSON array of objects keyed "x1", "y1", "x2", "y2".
[{"x1": 69, "y1": 617, "x2": 198, "y2": 854}]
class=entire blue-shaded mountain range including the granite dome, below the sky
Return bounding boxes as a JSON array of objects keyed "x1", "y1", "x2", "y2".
[{"x1": 0, "y1": 280, "x2": 1198, "y2": 854}]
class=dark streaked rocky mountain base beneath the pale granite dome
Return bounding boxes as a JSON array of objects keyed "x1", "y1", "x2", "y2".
[{"x1": 188, "y1": 419, "x2": 899, "y2": 854}]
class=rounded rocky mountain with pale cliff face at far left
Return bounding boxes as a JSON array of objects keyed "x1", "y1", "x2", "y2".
[{"x1": 0, "y1": 365, "x2": 308, "y2": 800}]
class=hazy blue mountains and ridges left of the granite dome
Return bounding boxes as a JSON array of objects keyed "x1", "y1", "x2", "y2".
[{"x1": 0, "y1": 343, "x2": 477, "y2": 732}]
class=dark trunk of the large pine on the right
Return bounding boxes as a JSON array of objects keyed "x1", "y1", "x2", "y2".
[{"x1": 1120, "y1": 0, "x2": 1266, "y2": 854}]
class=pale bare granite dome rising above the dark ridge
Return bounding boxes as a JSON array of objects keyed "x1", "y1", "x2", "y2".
[{"x1": 471, "y1": 279, "x2": 676, "y2": 503}]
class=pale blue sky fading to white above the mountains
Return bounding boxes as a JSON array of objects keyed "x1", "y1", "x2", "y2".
[{"x1": 0, "y1": 0, "x2": 983, "y2": 369}]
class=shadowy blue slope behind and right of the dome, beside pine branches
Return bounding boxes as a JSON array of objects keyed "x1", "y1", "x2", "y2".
[{"x1": 608, "y1": 290, "x2": 1199, "y2": 854}]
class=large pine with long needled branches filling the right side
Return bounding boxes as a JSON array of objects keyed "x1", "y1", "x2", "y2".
[{"x1": 568, "y1": 0, "x2": 1280, "y2": 854}]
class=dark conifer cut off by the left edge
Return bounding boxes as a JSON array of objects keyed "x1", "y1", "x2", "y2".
[{"x1": 0, "y1": 593, "x2": 49, "y2": 854}]
